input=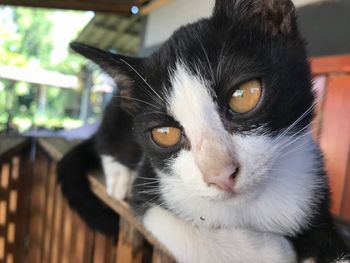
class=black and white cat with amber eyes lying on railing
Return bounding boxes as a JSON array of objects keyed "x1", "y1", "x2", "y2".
[{"x1": 58, "y1": 0, "x2": 350, "y2": 263}]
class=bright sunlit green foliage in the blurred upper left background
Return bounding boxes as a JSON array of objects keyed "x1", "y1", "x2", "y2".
[{"x1": 0, "y1": 7, "x2": 91, "y2": 133}]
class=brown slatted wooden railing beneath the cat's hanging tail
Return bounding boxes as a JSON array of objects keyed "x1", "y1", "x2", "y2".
[{"x1": 0, "y1": 137, "x2": 174, "y2": 263}]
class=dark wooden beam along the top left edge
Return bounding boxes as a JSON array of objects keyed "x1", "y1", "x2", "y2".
[{"x1": 0, "y1": 0, "x2": 144, "y2": 15}]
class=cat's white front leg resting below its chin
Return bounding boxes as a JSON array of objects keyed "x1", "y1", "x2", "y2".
[{"x1": 143, "y1": 206, "x2": 296, "y2": 263}]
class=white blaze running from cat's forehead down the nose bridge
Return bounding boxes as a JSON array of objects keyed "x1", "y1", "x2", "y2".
[{"x1": 167, "y1": 63, "x2": 236, "y2": 186}]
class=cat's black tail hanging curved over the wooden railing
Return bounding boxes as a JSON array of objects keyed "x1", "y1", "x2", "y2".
[{"x1": 57, "y1": 138, "x2": 118, "y2": 235}]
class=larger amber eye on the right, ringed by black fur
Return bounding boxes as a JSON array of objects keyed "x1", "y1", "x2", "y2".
[{"x1": 229, "y1": 79, "x2": 262, "y2": 113}]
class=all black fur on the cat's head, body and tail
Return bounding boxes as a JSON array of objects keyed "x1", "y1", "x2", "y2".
[{"x1": 58, "y1": 0, "x2": 350, "y2": 262}]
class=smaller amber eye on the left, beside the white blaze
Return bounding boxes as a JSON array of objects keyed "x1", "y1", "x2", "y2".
[{"x1": 151, "y1": 127, "x2": 181, "y2": 147}]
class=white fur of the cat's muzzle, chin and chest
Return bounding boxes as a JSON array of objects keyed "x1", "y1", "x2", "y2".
[{"x1": 159, "y1": 134, "x2": 322, "y2": 235}]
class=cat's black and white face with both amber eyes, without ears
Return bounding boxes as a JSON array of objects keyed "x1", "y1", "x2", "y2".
[{"x1": 134, "y1": 1, "x2": 313, "y2": 200}]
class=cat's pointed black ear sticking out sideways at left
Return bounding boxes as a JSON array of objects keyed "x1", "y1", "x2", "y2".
[{"x1": 70, "y1": 42, "x2": 142, "y2": 89}]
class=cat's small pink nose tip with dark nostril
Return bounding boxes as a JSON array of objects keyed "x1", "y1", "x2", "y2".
[{"x1": 207, "y1": 165, "x2": 239, "y2": 192}]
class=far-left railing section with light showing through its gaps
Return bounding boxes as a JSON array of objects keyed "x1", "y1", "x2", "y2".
[{"x1": 0, "y1": 138, "x2": 31, "y2": 263}]
